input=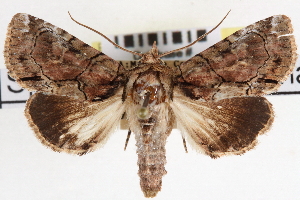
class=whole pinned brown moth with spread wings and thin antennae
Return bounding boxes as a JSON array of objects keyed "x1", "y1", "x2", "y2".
[{"x1": 4, "y1": 13, "x2": 297, "y2": 197}]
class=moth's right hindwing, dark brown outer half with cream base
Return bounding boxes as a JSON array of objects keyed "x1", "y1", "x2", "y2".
[{"x1": 170, "y1": 90, "x2": 274, "y2": 158}]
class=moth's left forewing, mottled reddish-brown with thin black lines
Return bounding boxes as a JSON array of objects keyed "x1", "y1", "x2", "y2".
[{"x1": 4, "y1": 13, "x2": 123, "y2": 100}]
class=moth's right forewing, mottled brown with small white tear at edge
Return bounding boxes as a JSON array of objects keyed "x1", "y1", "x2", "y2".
[{"x1": 178, "y1": 15, "x2": 297, "y2": 101}]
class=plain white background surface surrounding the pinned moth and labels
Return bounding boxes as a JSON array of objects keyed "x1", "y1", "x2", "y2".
[{"x1": 0, "y1": 0, "x2": 300, "y2": 200}]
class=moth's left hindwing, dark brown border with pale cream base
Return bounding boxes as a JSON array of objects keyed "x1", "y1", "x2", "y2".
[{"x1": 25, "y1": 90, "x2": 126, "y2": 155}]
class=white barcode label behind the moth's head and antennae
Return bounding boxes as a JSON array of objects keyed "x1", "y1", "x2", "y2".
[{"x1": 98, "y1": 27, "x2": 221, "y2": 60}]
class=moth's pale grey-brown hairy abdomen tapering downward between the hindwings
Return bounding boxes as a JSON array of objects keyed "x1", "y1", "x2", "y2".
[{"x1": 126, "y1": 103, "x2": 174, "y2": 197}]
